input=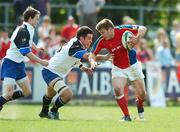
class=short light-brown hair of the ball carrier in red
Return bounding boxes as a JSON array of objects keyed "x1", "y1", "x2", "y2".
[{"x1": 96, "y1": 18, "x2": 114, "y2": 31}]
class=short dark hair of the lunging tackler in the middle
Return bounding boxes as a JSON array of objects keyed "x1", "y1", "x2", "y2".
[{"x1": 76, "y1": 26, "x2": 93, "y2": 39}]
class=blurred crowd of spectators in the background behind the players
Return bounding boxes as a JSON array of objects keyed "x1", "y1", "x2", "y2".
[{"x1": 0, "y1": 0, "x2": 180, "y2": 75}]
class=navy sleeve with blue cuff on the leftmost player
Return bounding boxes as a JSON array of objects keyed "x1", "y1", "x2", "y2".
[{"x1": 14, "y1": 28, "x2": 31, "y2": 55}]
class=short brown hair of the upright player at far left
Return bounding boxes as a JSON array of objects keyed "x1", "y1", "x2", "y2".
[{"x1": 23, "y1": 6, "x2": 40, "y2": 22}]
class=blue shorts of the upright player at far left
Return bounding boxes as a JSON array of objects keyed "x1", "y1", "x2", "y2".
[{"x1": 1, "y1": 58, "x2": 26, "y2": 80}]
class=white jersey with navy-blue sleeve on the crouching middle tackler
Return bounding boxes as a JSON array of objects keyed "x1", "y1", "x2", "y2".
[{"x1": 46, "y1": 37, "x2": 88, "y2": 78}]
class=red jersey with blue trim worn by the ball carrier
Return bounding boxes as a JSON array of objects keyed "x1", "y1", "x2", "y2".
[{"x1": 91, "y1": 25, "x2": 139, "y2": 69}]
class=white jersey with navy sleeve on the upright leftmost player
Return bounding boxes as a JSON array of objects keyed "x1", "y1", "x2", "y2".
[{"x1": 5, "y1": 22, "x2": 34, "y2": 63}]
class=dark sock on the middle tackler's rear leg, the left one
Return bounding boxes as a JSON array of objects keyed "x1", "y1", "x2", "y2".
[{"x1": 41, "y1": 95, "x2": 52, "y2": 114}]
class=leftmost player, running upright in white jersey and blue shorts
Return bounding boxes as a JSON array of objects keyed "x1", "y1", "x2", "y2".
[{"x1": 0, "y1": 7, "x2": 48, "y2": 110}]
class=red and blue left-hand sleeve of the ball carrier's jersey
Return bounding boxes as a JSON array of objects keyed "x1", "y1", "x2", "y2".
[{"x1": 90, "y1": 36, "x2": 104, "y2": 54}]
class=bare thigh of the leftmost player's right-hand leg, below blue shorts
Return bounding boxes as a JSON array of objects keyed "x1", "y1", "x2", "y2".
[{"x1": 17, "y1": 76, "x2": 31, "y2": 96}]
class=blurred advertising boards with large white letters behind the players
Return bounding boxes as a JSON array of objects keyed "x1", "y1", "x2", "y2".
[{"x1": 0, "y1": 62, "x2": 180, "y2": 106}]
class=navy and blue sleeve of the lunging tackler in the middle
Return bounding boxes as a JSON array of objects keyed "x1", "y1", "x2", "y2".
[{"x1": 69, "y1": 44, "x2": 88, "y2": 59}]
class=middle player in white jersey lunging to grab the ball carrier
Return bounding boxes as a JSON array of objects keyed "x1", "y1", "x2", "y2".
[{"x1": 39, "y1": 26, "x2": 111, "y2": 119}]
